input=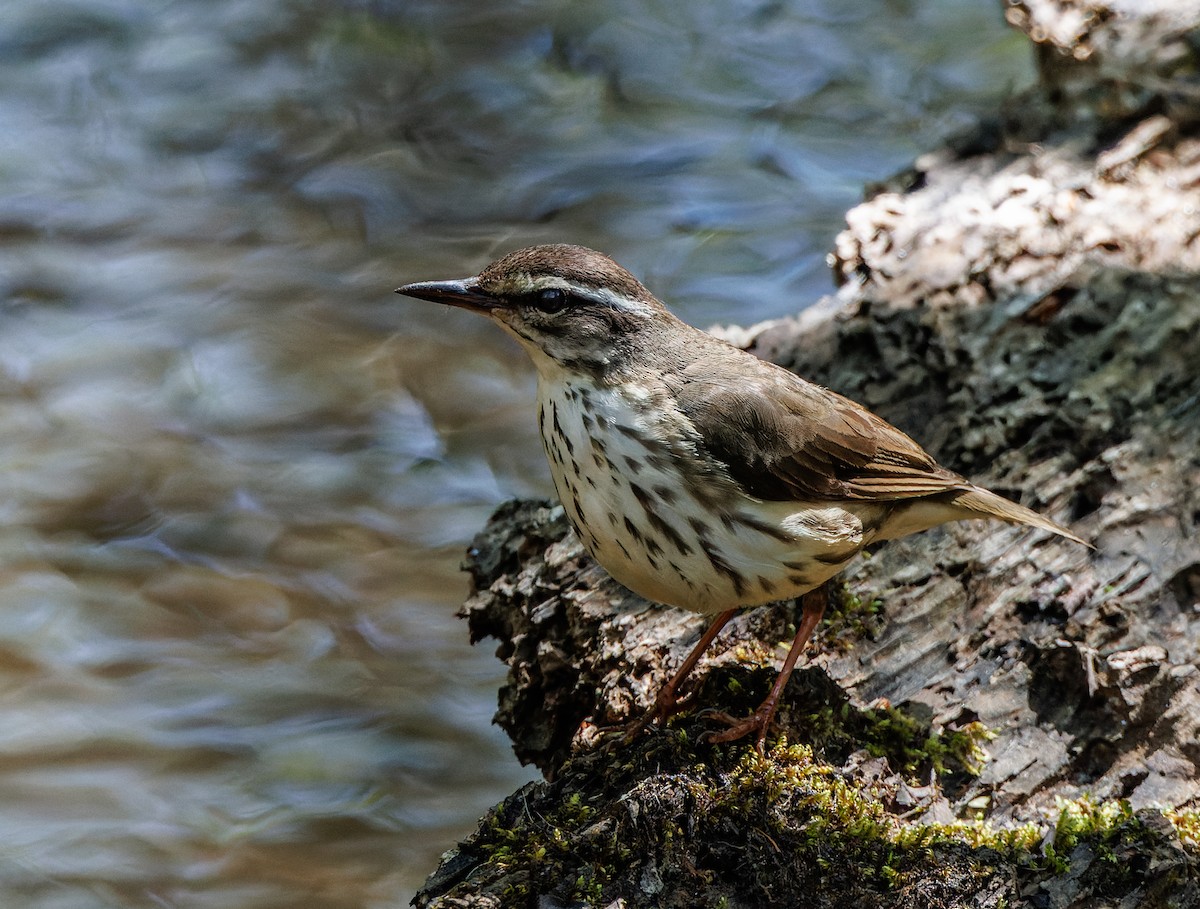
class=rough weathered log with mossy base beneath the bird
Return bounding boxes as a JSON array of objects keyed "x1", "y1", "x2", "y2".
[{"x1": 414, "y1": 0, "x2": 1200, "y2": 907}]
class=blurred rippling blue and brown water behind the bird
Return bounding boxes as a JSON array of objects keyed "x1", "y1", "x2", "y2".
[{"x1": 0, "y1": 0, "x2": 1030, "y2": 909}]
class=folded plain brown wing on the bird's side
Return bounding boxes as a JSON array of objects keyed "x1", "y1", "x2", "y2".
[{"x1": 676, "y1": 355, "x2": 970, "y2": 501}]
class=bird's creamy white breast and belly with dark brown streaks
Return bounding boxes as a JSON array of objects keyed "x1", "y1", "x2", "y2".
[{"x1": 538, "y1": 380, "x2": 874, "y2": 613}]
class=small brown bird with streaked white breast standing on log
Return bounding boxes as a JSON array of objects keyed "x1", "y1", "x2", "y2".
[{"x1": 396, "y1": 245, "x2": 1086, "y2": 746}]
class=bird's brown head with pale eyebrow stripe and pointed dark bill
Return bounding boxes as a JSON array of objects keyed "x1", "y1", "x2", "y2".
[{"x1": 396, "y1": 245, "x2": 676, "y2": 372}]
